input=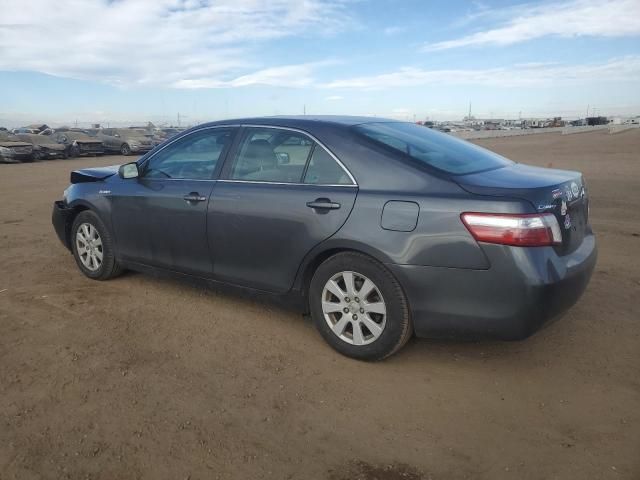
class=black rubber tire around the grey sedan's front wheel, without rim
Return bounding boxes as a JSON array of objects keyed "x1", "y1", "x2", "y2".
[{"x1": 70, "y1": 210, "x2": 123, "y2": 280}]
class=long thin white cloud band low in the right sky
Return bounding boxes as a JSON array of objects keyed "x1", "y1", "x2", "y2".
[{"x1": 323, "y1": 55, "x2": 640, "y2": 89}]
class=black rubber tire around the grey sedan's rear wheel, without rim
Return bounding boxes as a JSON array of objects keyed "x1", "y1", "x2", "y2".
[{"x1": 309, "y1": 252, "x2": 413, "y2": 361}]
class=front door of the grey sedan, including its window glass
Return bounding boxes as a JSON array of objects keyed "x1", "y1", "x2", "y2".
[{"x1": 111, "y1": 128, "x2": 234, "y2": 276}]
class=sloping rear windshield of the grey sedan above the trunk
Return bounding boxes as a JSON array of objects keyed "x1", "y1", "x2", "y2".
[{"x1": 354, "y1": 122, "x2": 513, "y2": 175}]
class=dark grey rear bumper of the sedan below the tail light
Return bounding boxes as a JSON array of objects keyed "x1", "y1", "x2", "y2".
[{"x1": 389, "y1": 233, "x2": 597, "y2": 340}]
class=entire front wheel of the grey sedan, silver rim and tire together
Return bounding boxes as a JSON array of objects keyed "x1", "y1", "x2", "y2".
[{"x1": 71, "y1": 210, "x2": 122, "y2": 280}]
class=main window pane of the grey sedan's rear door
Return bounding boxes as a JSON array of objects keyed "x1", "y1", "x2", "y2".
[{"x1": 229, "y1": 128, "x2": 313, "y2": 183}]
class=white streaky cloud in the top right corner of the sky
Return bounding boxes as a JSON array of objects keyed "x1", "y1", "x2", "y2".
[{"x1": 424, "y1": 0, "x2": 640, "y2": 51}]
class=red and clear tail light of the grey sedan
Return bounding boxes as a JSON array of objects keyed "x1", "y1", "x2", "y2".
[{"x1": 460, "y1": 212, "x2": 562, "y2": 247}]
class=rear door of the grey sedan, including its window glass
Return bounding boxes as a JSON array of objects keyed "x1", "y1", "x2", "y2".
[{"x1": 207, "y1": 127, "x2": 357, "y2": 293}]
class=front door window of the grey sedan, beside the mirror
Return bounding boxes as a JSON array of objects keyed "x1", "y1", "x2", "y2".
[{"x1": 143, "y1": 128, "x2": 231, "y2": 180}]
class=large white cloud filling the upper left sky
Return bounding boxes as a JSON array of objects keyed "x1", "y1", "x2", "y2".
[{"x1": 0, "y1": 0, "x2": 350, "y2": 88}]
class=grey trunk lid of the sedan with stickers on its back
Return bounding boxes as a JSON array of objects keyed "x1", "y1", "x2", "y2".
[{"x1": 454, "y1": 163, "x2": 589, "y2": 255}]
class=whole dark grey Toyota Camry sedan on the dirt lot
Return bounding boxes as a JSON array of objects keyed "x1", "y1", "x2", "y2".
[{"x1": 53, "y1": 116, "x2": 597, "y2": 360}]
